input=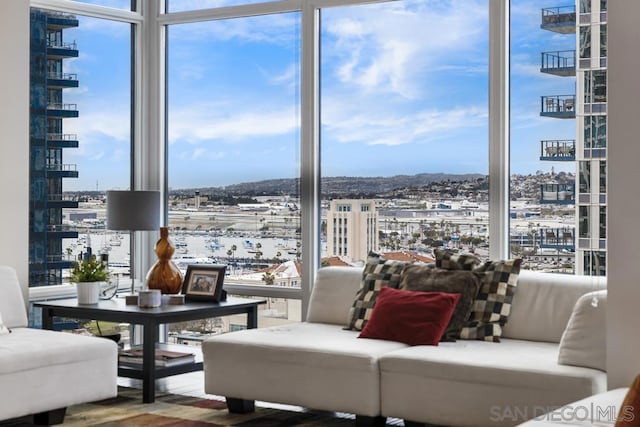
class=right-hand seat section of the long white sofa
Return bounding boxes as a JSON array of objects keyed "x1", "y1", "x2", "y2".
[{"x1": 379, "y1": 339, "x2": 607, "y2": 426}]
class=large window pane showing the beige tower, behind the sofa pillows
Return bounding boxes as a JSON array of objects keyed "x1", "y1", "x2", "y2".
[{"x1": 320, "y1": 0, "x2": 489, "y2": 263}]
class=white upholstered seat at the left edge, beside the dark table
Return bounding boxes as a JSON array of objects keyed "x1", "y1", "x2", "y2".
[{"x1": 0, "y1": 266, "x2": 118, "y2": 425}]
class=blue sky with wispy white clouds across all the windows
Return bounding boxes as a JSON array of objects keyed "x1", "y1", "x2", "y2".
[{"x1": 57, "y1": 0, "x2": 575, "y2": 190}]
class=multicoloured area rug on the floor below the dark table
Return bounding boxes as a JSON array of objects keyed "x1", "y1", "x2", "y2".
[{"x1": 0, "y1": 387, "x2": 402, "y2": 427}]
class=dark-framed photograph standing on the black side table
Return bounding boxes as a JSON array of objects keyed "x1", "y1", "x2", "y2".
[{"x1": 182, "y1": 264, "x2": 227, "y2": 302}]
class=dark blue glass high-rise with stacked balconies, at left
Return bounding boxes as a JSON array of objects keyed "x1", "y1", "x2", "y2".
[{"x1": 29, "y1": 9, "x2": 78, "y2": 286}]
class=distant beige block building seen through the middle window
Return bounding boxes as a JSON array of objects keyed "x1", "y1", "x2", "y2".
[{"x1": 327, "y1": 199, "x2": 378, "y2": 261}]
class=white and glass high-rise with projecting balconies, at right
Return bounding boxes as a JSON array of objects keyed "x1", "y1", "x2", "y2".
[{"x1": 540, "y1": 0, "x2": 607, "y2": 276}]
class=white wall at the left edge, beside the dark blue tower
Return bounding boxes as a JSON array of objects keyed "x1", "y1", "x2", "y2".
[{"x1": 0, "y1": 0, "x2": 29, "y2": 296}]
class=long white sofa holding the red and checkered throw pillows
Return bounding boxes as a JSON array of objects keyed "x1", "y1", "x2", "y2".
[{"x1": 203, "y1": 267, "x2": 606, "y2": 426}]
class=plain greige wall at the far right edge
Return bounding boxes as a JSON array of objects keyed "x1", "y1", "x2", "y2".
[{"x1": 607, "y1": 1, "x2": 640, "y2": 388}]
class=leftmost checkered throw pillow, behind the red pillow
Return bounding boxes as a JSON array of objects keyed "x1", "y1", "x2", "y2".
[{"x1": 346, "y1": 252, "x2": 408, "y2": 331}]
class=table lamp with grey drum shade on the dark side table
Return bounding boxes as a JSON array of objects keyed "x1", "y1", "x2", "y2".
[{"x1": 107, "y1": 191, "x2": 160, "y2": 293}]
